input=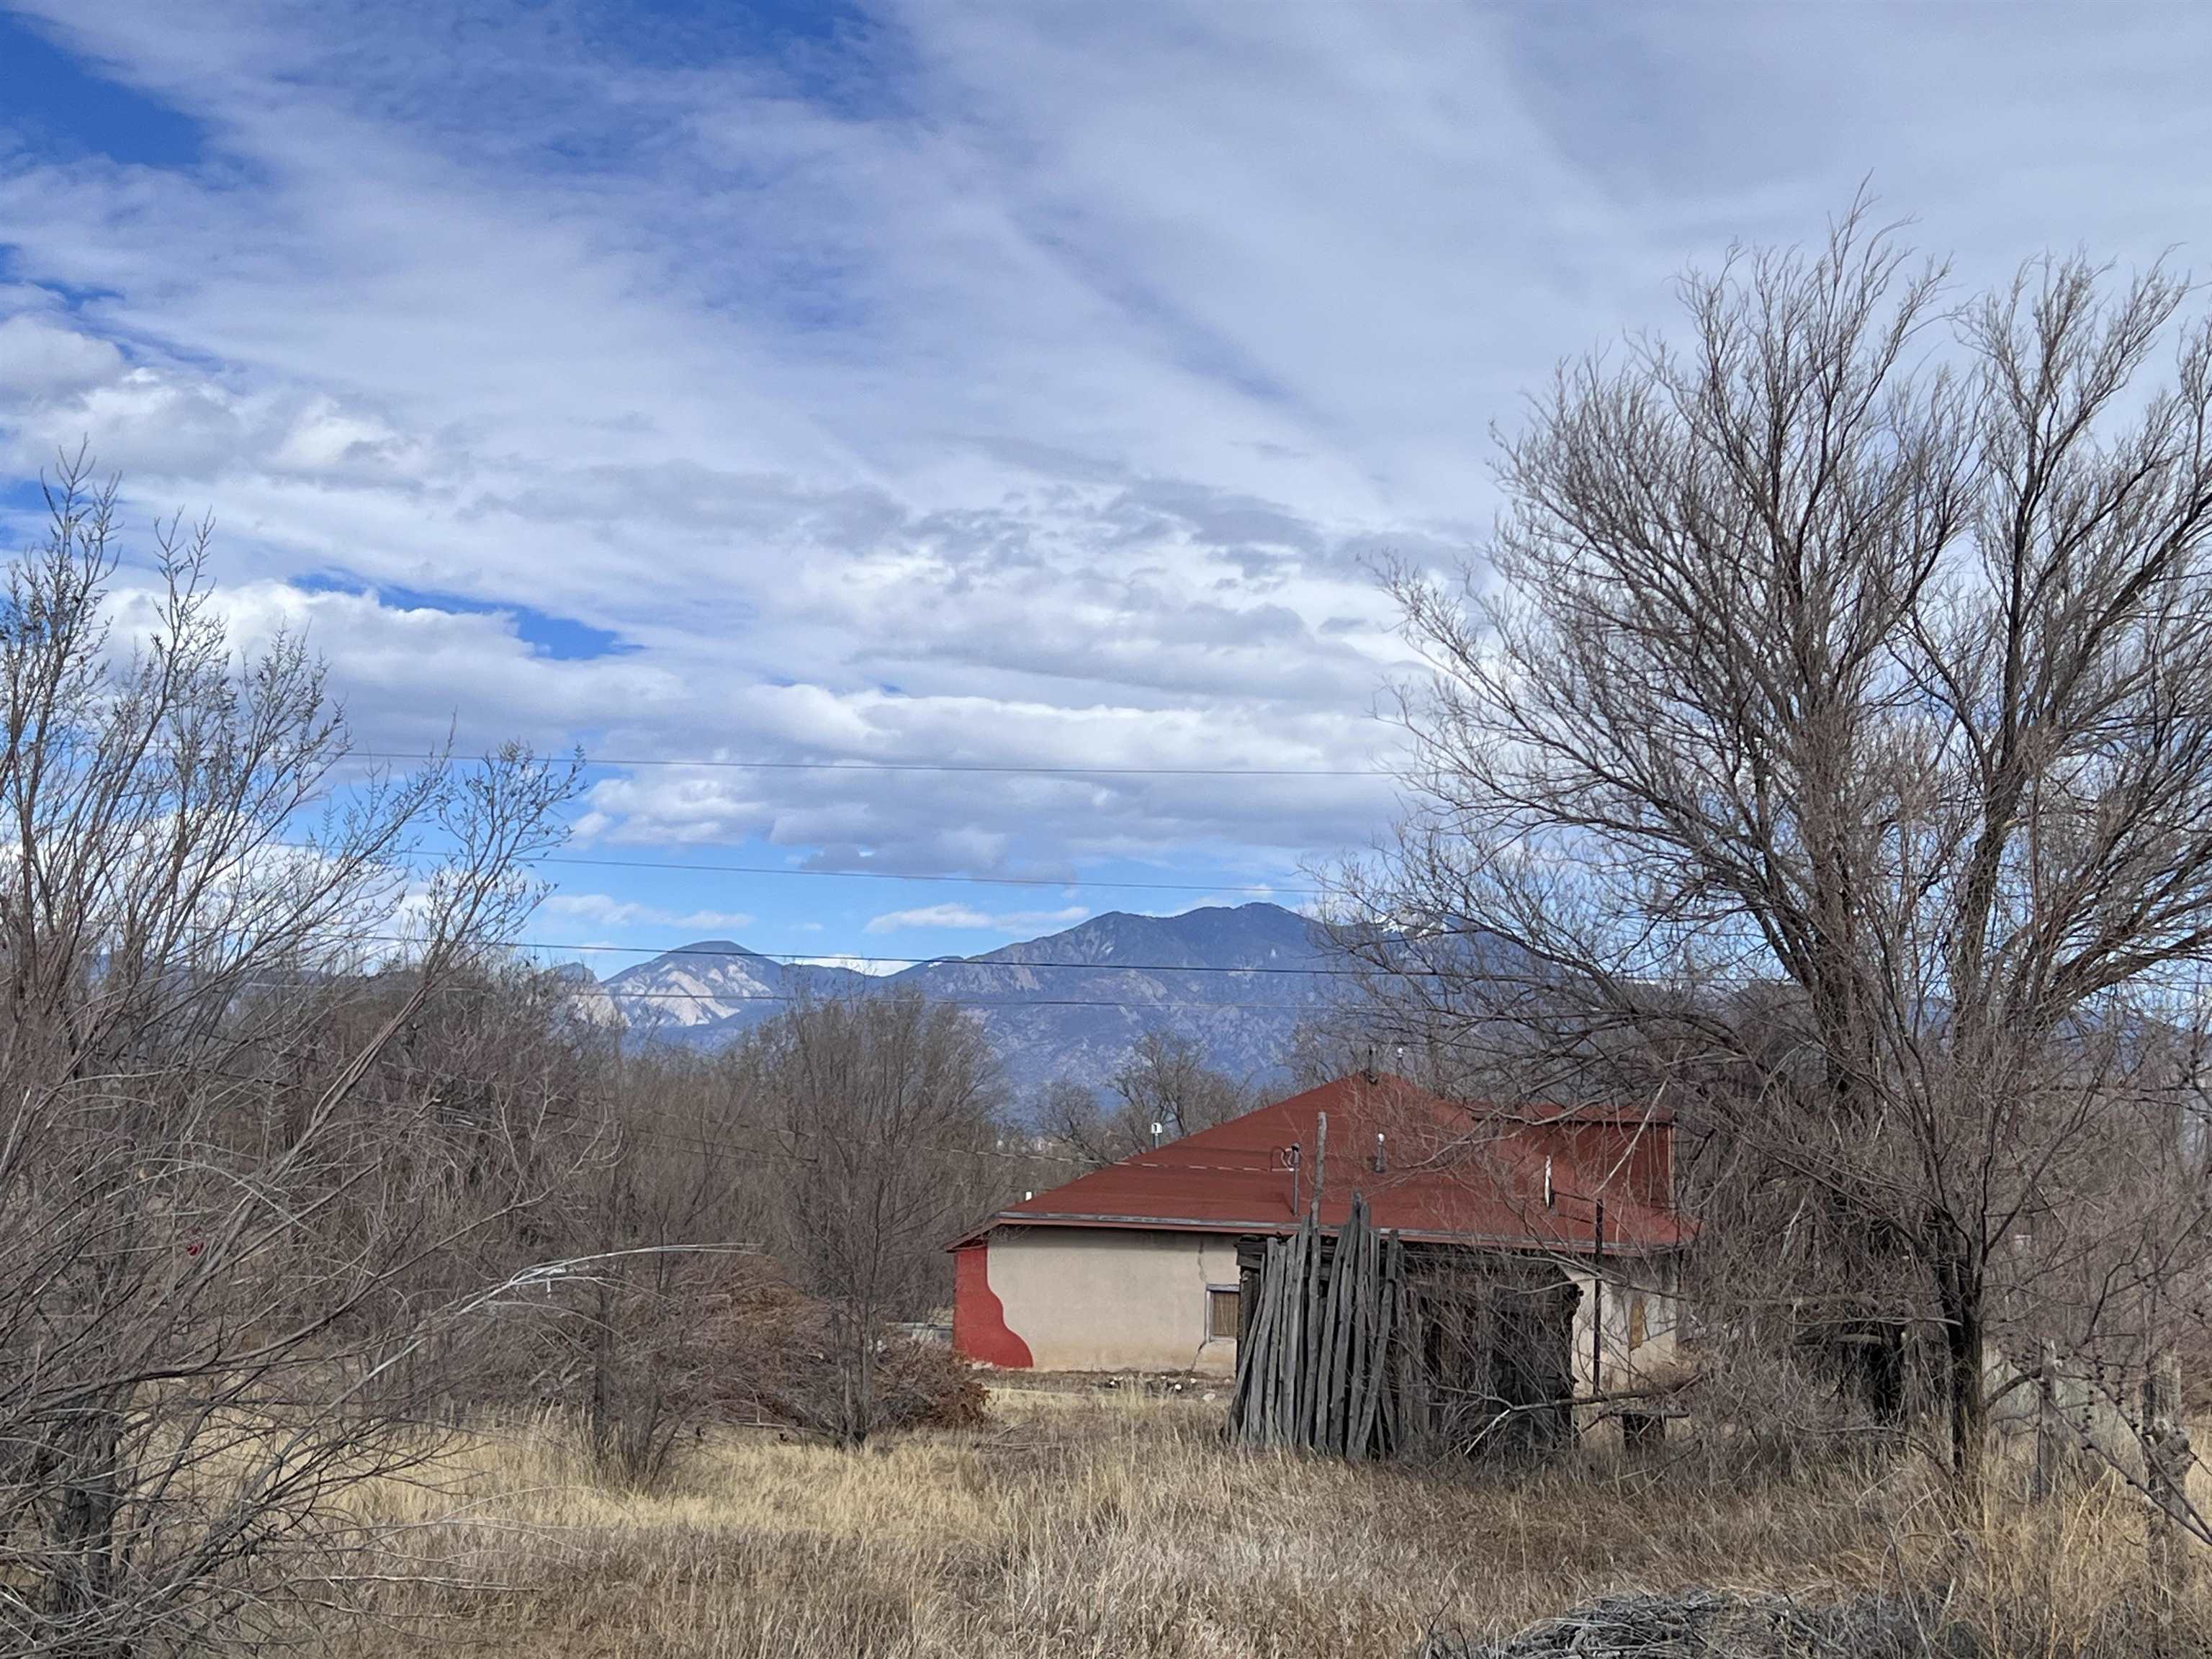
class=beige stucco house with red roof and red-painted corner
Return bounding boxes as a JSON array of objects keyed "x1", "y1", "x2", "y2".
[{"x1": 951, "y1": 1073, "x2": 1692, "y2": 1433}]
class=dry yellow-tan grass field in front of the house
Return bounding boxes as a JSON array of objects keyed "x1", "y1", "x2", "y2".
[{"x1": 336, "y1": 1389, "x2": 2194, "y2": 1659}]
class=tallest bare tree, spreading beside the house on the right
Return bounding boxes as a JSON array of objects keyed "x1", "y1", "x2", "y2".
[{"x1": 1343, "y1": 212, "x2": 2212, "y2": 1480}]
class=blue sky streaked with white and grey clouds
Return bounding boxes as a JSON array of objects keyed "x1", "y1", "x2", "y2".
[{"x1": 0, "y1": 0, "x2": 2212, "y2": 971}]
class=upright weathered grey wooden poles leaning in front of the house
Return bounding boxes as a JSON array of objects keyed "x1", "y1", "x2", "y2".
[{"x1": 1230, "y1": 1192, "x2": 1416, "y2": 1462}]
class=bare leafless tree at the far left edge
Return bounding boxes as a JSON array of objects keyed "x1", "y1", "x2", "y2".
[{"x1": 0, "y1": 458, "x2": 573, "y2": 1657}]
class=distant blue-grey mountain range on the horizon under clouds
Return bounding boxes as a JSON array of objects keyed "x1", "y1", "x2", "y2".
[{"x1": 593, "y1": 904, "x2": 1341, "y2": 1104}]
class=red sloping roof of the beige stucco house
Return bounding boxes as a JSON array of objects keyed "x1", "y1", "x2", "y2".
[{"x1": 953, "y1": 1075, "x2": 1692, "y2": 1254}]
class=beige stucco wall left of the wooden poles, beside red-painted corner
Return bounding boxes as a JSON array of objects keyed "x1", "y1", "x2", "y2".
[{"x1": 984, "y1": 1228, "x2": 1236, "y2": 1376}]
